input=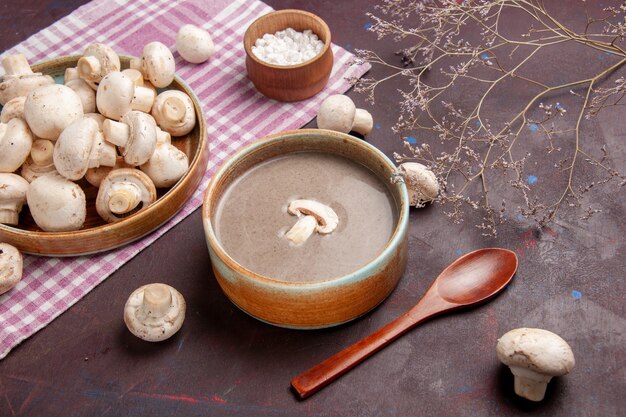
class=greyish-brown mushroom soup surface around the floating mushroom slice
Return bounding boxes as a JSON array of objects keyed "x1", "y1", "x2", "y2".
[{"x1": 212, "y1": 152, "x2": 398, "y2": 281}]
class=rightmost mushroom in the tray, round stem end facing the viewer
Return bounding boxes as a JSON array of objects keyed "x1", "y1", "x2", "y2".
[{"x1": 152, "y1": 90, "x2": 196, "y2": 136}]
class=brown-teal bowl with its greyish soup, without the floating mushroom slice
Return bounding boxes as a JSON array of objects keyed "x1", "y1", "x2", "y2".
[{"x1": 202, "y1": 129, "x2": 409, "y2": 329}]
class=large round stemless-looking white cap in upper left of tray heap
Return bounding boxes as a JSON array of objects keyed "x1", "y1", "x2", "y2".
[{"x1": 24, "y1": 84, "x2": 84, "y2": 140}]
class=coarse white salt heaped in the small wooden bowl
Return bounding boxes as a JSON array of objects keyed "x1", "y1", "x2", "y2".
[{"x1": 252, "y1": 28, "x2": 324, "y2": 65}]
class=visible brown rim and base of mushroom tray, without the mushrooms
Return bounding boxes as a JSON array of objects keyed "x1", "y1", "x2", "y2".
[{"x1": 0, "y1": 56, "x2": 209, "y2": 256}]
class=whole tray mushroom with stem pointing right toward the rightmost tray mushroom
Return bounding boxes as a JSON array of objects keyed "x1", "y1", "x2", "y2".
[{"x1": 96, "y1": 71, "x2": 155, "y2": 120}]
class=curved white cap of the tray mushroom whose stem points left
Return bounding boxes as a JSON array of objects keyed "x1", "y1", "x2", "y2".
[{"x1": 121, "y1": 110, "x2": 157, "y2": 166}]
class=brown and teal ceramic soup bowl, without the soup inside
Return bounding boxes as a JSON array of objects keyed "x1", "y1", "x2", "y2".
[{"x1": 202, "y1": 129, "x2": 409, "y2": 329}]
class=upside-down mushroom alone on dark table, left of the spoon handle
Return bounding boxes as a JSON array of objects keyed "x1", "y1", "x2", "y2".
[{"x1": 124, "y1": 283, "x2": 186, "y2": 342}]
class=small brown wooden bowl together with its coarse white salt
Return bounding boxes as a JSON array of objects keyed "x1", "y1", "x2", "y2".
[{"x1": 243, "y1": 10, "x2": 333, "y2": 101}]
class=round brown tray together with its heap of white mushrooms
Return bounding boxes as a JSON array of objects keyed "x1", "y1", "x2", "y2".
[{"x1": 0, "y1": 50, "x2": 208, "y2": 256}]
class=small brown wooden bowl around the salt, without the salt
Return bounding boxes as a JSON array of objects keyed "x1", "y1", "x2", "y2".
[{"x1": 243, "y1": 10, "x2": 333, "y2": 102}]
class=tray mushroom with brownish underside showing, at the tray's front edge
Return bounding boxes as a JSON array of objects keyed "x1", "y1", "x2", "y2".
[{"x1": 96, "y1": 168, "x2": 156, "y2": 223}]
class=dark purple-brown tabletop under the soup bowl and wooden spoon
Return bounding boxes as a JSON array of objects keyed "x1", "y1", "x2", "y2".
[{"x1": 0, "y1": 0, "x2": 626, "y2": 416}]
